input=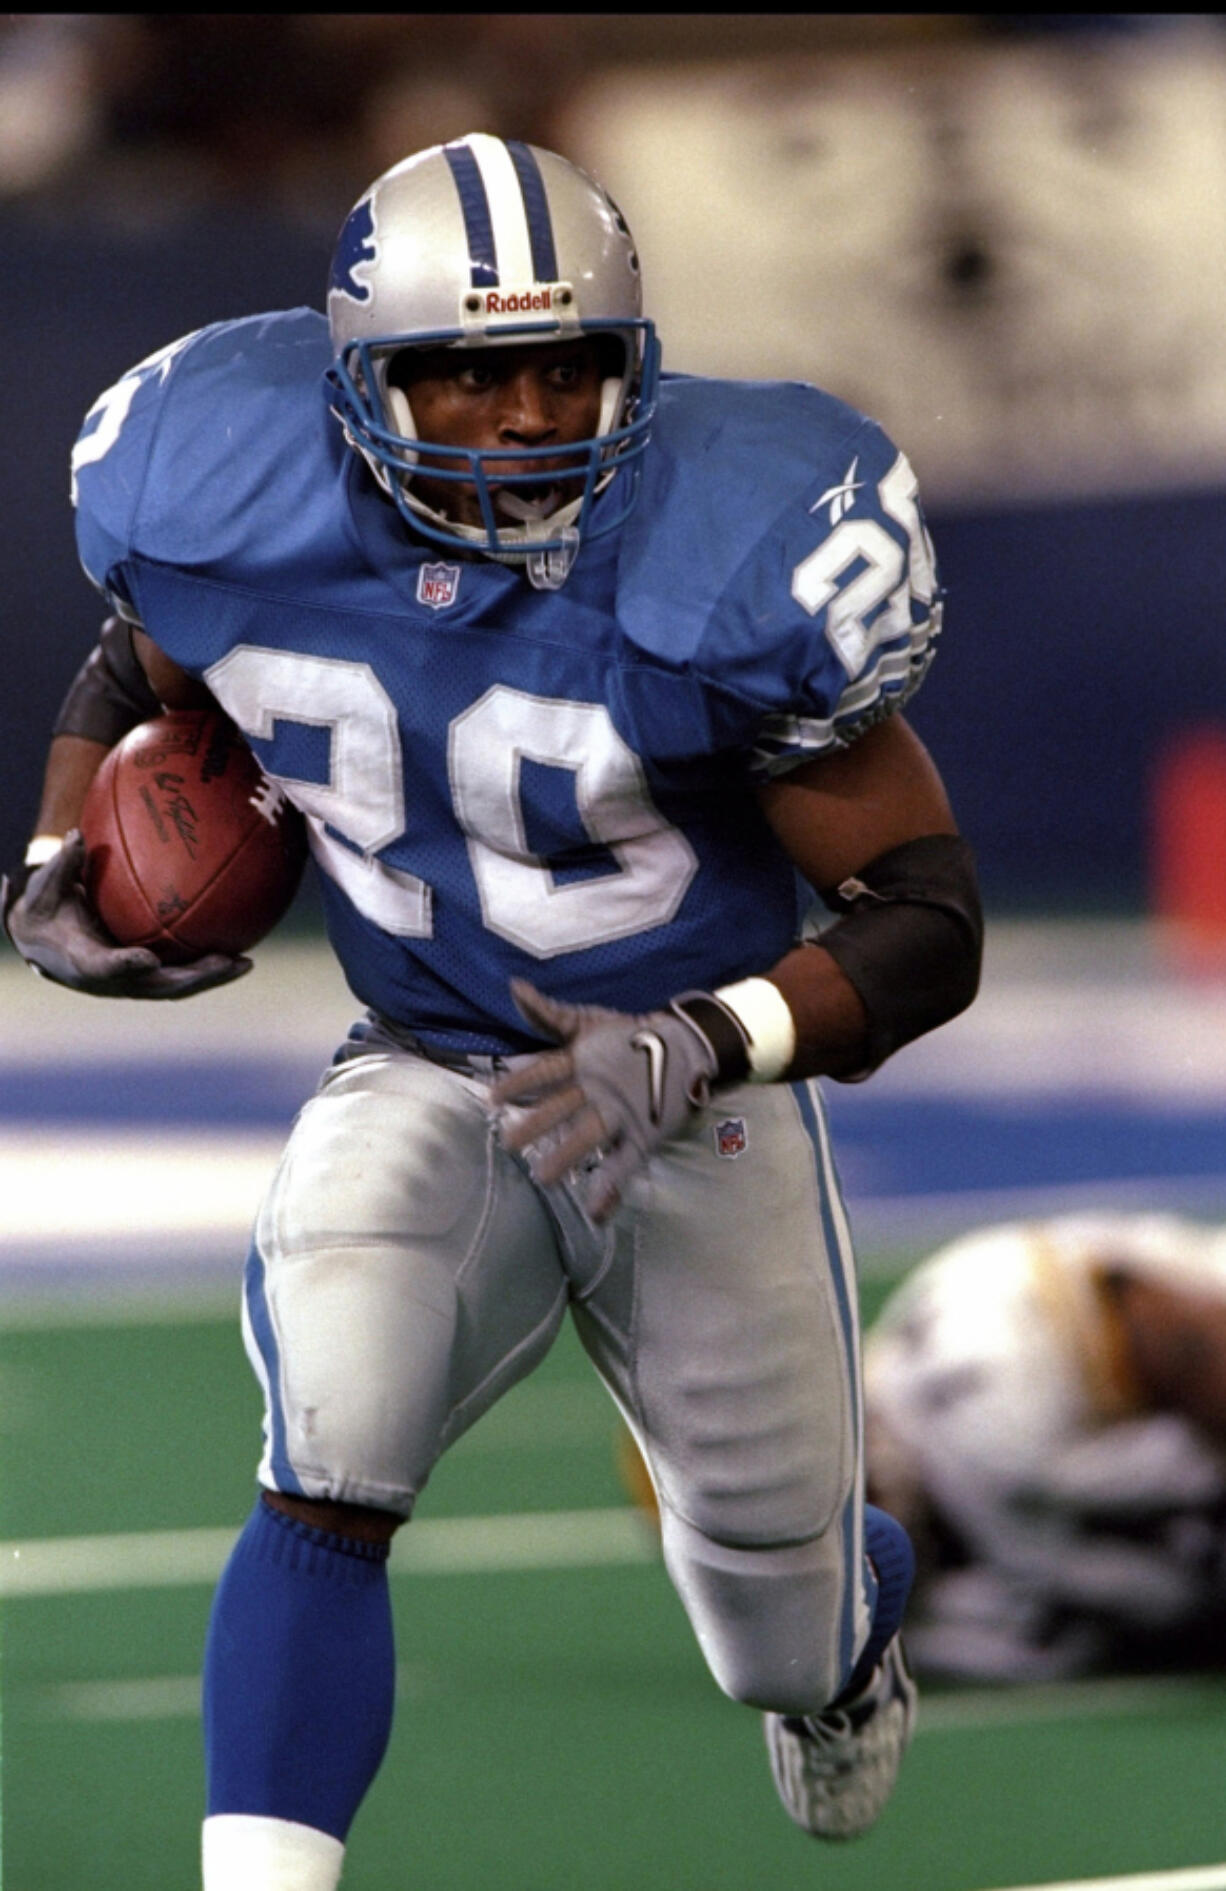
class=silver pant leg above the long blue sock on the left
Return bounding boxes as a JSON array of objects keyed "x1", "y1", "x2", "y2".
[{"x1": 246, "y1": 1053, "x2": 566, "y2": 1515}]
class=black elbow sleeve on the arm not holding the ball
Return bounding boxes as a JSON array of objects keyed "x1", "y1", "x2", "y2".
[{"x1": 815, "y1": 834, "x2": 984, "y2": 1084}]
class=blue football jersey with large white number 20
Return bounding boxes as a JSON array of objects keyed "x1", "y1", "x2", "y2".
[{"x1": 74, "y1": 310, "x2": 940, "y2": 1051}]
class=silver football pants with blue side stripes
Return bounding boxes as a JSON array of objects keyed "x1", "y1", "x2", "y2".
[{"x1": 244, "y1": 1032, "x2": 872, "y2": 1713}]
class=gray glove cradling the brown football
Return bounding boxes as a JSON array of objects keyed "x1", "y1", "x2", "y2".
[{"x1": 0, "y1": 828, "x2": 252, "y2": 998}]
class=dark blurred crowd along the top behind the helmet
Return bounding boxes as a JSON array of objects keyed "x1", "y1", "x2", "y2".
[{"x1": 0, "y1": 13, "x2": 1195, "y2": 219}]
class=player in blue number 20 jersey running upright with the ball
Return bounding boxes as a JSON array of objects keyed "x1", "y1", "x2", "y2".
[{"x1": 6, "y1": 134, "x2": 982, "y2": 1891}]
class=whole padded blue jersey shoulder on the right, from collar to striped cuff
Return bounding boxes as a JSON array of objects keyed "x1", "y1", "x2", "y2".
[{"x1": 619, "y1": 380, "x2": 940, "y2": 773}]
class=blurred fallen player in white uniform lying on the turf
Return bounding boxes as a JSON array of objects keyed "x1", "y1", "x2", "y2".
[{"x1": 865, "y1": 1214, "x2": 1226, "y2": 1681}]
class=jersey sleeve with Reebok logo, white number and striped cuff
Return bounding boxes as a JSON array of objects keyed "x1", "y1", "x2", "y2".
[{"x1": 749, "y1": 420, "x2": 942, "y2": 777}]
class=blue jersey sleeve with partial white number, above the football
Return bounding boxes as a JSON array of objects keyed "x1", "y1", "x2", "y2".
[{"x1": 72, "y1": 335, "x2": 195, "y2": 622}]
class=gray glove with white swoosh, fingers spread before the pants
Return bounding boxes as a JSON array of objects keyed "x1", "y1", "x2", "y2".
[{"x1": 490, "y1": 978, "x2": 744, "y2": 1222}]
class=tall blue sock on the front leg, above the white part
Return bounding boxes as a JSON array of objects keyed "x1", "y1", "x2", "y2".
[{"x1": 204, "y1": 1501, "x2": 395, "y2": 1842}]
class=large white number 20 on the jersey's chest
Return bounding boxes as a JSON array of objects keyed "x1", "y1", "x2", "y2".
[{"x1": 204, "y1": 643, "x2": 698, "y2": 959}]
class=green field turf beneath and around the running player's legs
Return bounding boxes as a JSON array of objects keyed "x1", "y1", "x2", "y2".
[{"x1": 0, "y1": 1278, "x2": 1226, "y2": 1891}]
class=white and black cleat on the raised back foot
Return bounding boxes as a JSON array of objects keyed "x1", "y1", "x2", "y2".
[{"x1": 766, "y1": 1636, "x2": 918, "y2": 1838}]
